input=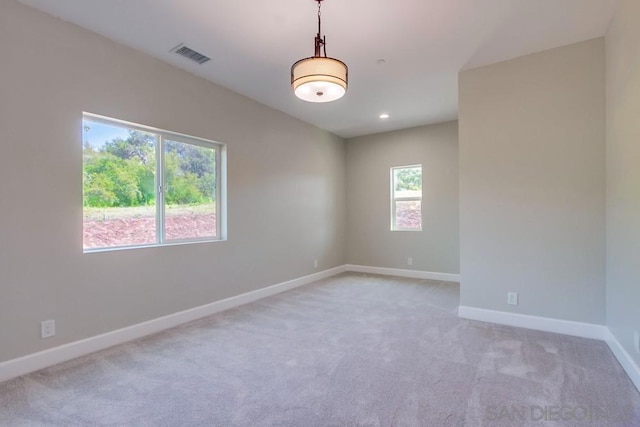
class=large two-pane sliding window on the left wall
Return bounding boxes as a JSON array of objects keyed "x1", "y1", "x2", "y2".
[{"x1": 82, "y1": 113, "x2": 224, "y2": 251}]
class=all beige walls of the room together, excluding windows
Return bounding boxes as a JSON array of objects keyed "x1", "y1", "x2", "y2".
[{"x1": 0, "y1": 0, "x2": 640, "y2": 370}]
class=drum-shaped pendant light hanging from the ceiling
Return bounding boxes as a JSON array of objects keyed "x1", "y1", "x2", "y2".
[{"x1": 291, "y1": 0, "x2": 349, "y2": 102}]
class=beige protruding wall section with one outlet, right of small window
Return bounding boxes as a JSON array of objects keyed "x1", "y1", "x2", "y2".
[{"x1": 459, "y1": 38, "x2": 605, "y2": 324}]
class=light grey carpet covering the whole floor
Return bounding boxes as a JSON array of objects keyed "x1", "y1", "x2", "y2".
[{"x1": 0, "y1": 274, "x2": 640, "y2": 427}]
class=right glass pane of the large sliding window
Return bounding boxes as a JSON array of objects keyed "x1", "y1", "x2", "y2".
[{"x1": 164, "y1": 140, "x2": 217, "y2": 241}]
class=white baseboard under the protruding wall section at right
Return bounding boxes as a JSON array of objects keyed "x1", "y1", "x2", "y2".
[{"x1": 458, "y1": 305, "x2": 609, "y2": 340}]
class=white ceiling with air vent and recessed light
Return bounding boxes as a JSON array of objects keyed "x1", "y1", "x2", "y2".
[{"x1": 21, "y1": 0, "x2": 618, "y2": 137}]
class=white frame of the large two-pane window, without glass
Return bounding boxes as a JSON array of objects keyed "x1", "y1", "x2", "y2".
[{"x1": 80, "y1": 111, "x2": 227, "y2": 253}]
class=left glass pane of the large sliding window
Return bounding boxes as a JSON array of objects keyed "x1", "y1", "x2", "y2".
[{"x1": 82, "y1": 119, "x2": 157, "y2": 249}]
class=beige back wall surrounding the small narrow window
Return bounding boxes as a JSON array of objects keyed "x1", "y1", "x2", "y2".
[{"x1": 347, "y1": 122, "x2": 459, "y2": 274}]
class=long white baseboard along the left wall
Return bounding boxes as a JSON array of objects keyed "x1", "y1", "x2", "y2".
[{"x1": 0, "y1": 265, "x2": 346, "y2": 382}]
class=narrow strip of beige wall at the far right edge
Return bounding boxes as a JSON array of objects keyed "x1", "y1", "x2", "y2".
[{"x1": 606, "y1": 0, "x2": 640, "y2": 365}]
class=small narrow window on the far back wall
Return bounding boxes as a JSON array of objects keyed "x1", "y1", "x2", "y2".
[{"x1": 391, "y1": 165, "x2": 422, "y2": 231}]
